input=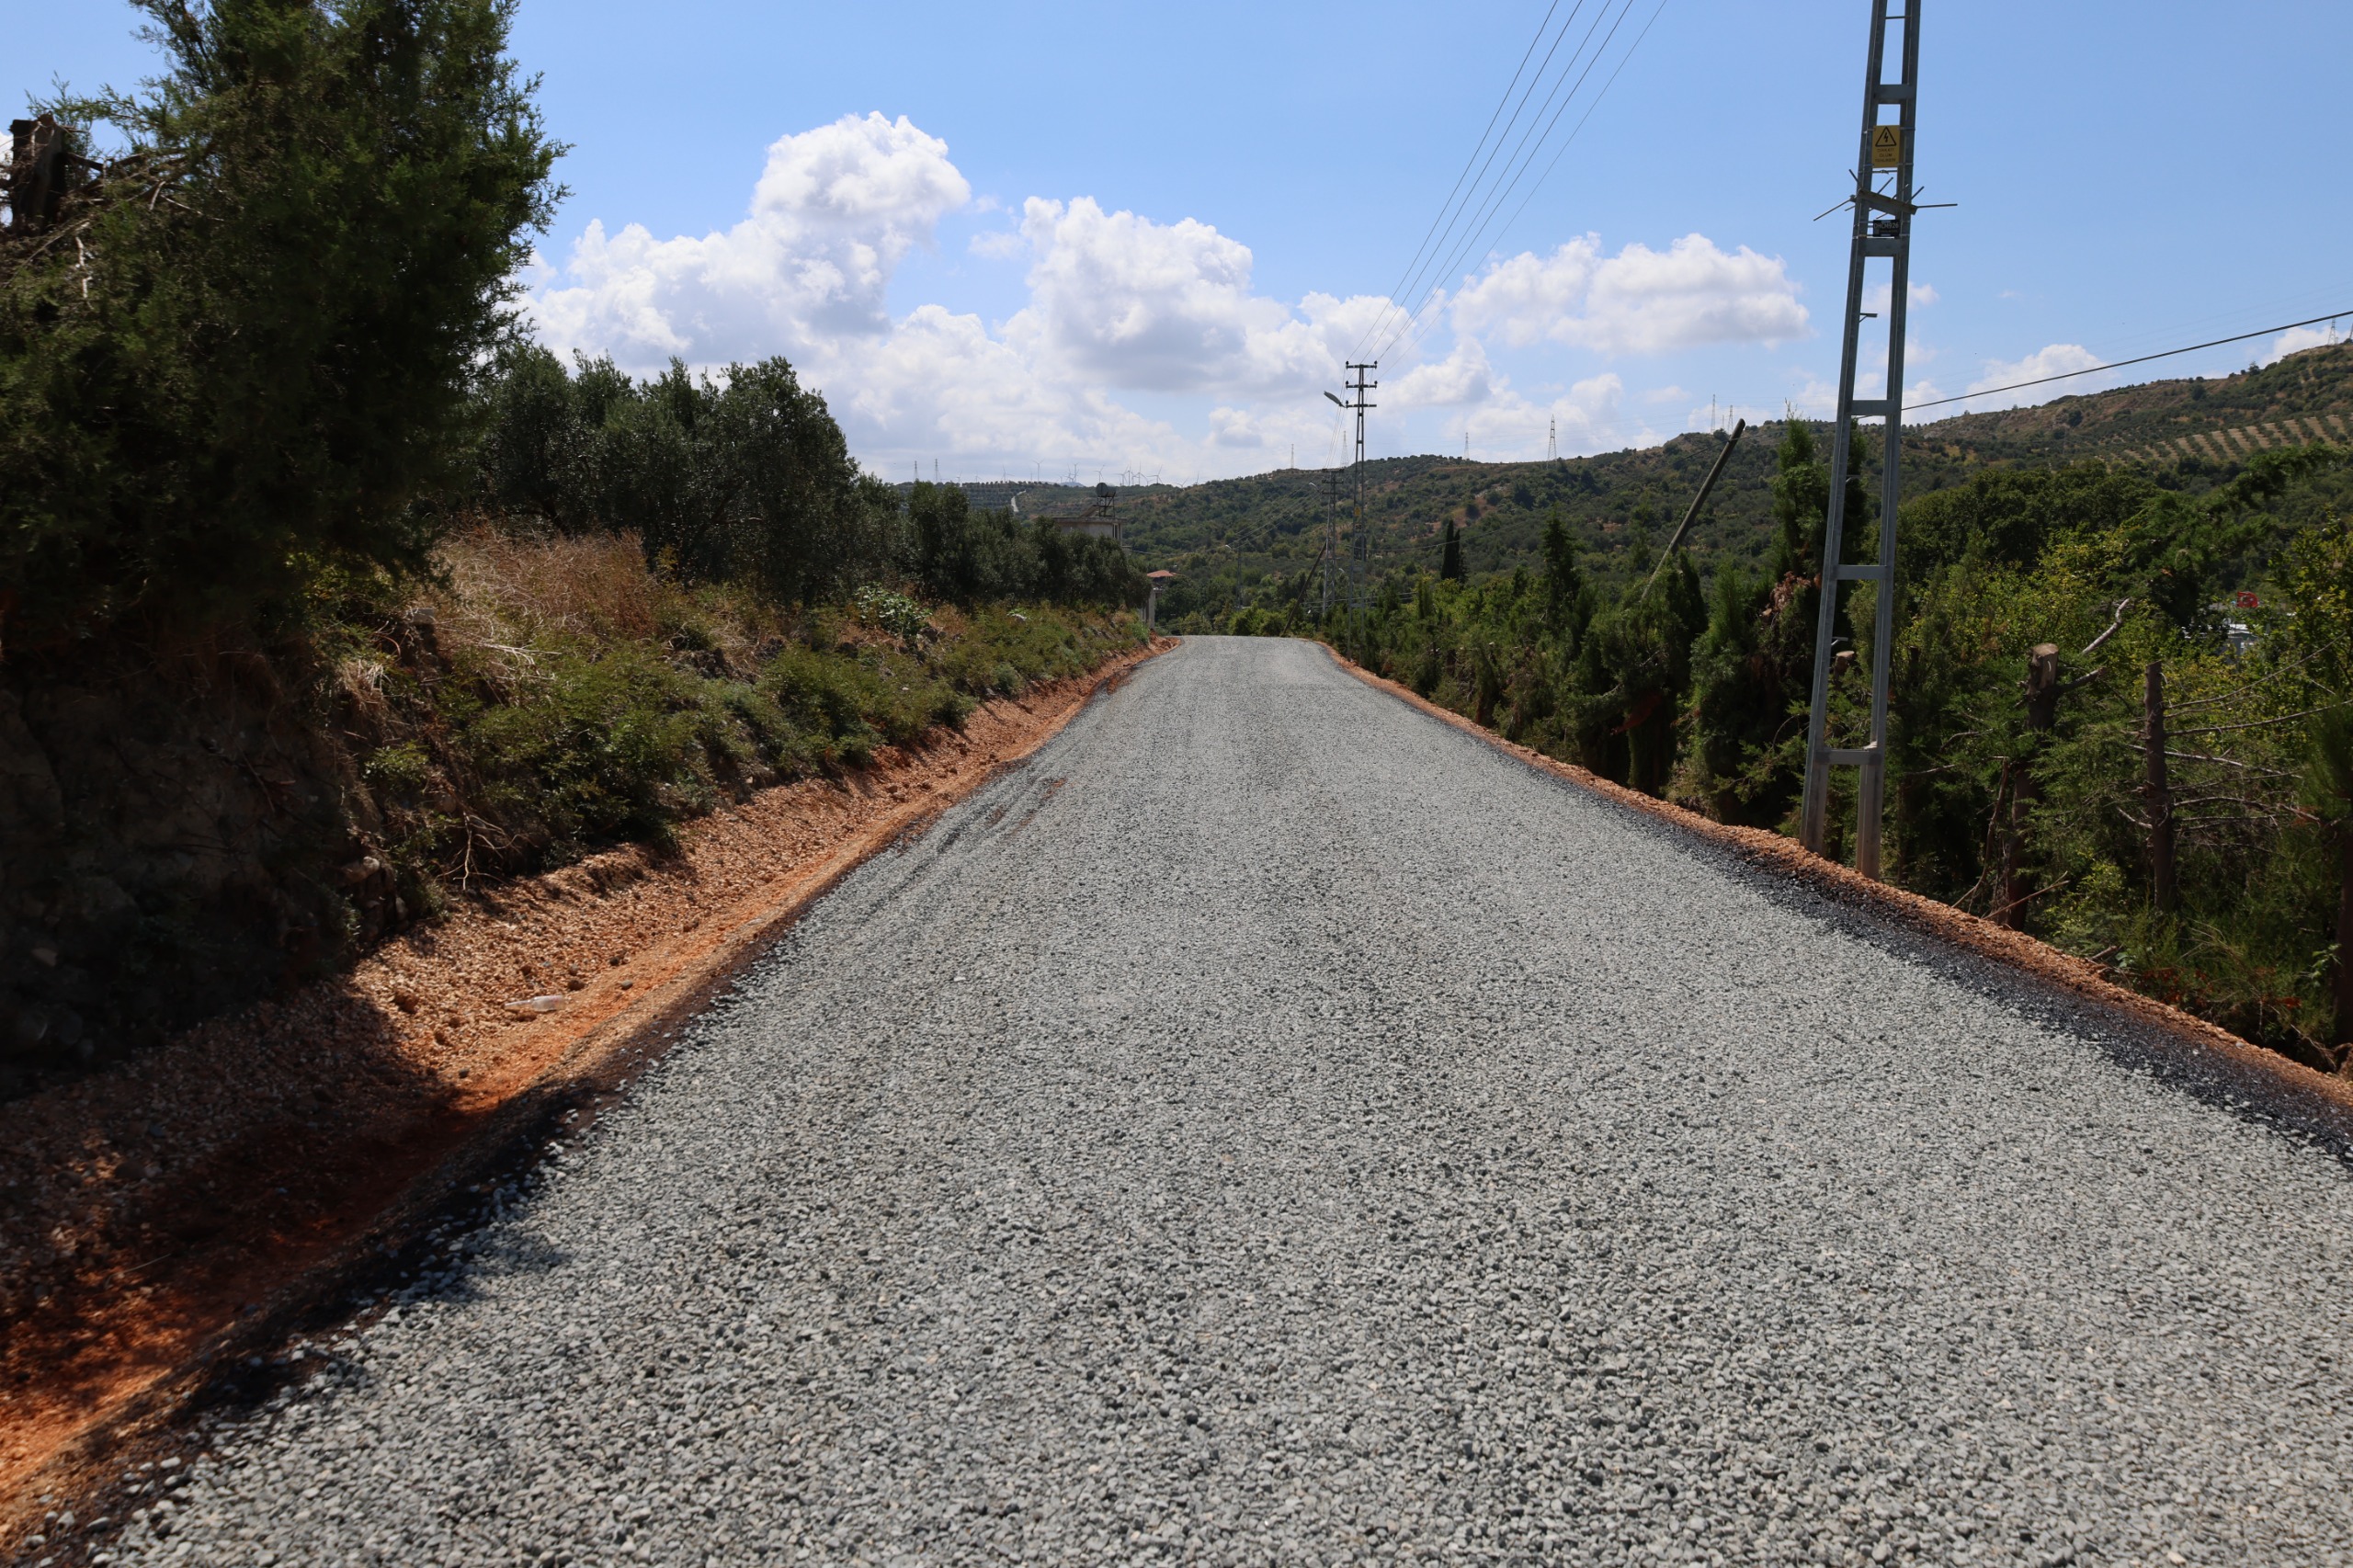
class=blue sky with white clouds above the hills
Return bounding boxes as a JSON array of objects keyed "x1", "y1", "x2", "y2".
[{"x1": 18, "y1": 0, "x2": 2353, "y2": 481}]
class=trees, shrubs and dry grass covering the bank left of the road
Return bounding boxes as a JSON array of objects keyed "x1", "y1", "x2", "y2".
[{"x1": 0, "y1": 0, "x2": 1143, "y2": 1074}]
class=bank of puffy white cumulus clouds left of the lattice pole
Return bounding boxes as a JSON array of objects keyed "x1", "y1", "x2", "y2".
[{"x1": 527, "y1": 113, "x2": 1807, "y2": 475}]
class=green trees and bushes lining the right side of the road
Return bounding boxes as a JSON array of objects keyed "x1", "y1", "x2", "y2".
[{"x1": 1222, "y1": 422, "x2": 2353, "y2": 1072}]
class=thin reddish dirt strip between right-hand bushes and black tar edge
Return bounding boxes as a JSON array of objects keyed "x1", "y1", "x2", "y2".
[{"x1": 1302, "y1": 638, "x2": 2353, "y2": 1114}]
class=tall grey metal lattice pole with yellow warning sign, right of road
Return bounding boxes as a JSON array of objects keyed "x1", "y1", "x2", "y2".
[{"x1": 1802, "y1": 0, "x2": 1920, "y2": 878}]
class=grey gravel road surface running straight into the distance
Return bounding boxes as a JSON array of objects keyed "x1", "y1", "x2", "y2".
[{"x1": 64, "y1": 638, "x2": 2353, "y2": 1565}]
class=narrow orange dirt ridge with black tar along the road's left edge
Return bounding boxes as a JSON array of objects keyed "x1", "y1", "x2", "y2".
[{"x1": 0, "y1": 636, "x2": 1176, "y2": 1568}]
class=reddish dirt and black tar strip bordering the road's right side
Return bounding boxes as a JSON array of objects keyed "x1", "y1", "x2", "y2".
[{"x1": 1315, "y1": 642, "x2": 2353, "y2": 1168}]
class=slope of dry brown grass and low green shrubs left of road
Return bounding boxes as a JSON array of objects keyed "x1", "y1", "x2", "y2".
[{"x1": 320, "y1": 528, "x2": 1134, "y2": 906}]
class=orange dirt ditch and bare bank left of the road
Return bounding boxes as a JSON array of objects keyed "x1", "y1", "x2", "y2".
[{"x1": 0, "y1": 641, "x2": 1172, "y2": 1547}]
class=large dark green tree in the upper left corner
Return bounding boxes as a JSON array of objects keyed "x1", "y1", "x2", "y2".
[{"x1": 0, "y1": 0, "x2": 555, "y2": 638}]
